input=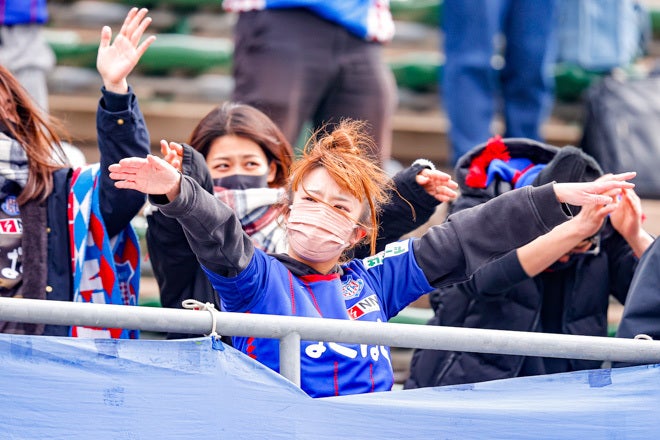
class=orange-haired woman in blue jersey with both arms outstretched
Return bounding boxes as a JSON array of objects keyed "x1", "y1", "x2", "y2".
[{"x1": 110, "y1": 121, "x2": 634, "y2": 397}]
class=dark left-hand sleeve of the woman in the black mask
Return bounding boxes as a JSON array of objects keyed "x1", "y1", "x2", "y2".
[{"x1": 147, "y1": 145, "x2": 219, "y2": 308}]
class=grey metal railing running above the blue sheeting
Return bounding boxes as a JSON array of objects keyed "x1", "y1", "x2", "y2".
[{"x1": 0, "y1": 298, "x2": 660, "y2": 385}]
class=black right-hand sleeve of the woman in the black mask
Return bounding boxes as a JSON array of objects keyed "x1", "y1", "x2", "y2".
[{"x1": 354, "y1": 164, "x2": 440, "y2": 258}]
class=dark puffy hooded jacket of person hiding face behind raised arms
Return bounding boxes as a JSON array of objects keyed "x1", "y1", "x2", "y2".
[{"x1": 405, "y1": 139, "x2": 637, "y2": 388}]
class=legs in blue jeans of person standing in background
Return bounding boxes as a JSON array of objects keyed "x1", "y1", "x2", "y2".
[{"x1": 441, "y1": 0, "x2": 557, "y2": 165}]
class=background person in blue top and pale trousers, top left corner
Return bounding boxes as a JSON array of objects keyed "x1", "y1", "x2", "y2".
[{"x1": 0, "y1": 0, "x2": 55, "y2": 113}]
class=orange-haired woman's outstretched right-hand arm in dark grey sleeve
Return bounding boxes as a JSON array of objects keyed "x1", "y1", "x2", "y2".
[{"x1": 414, "y1": 173, "x2": 634, "y2": 286}]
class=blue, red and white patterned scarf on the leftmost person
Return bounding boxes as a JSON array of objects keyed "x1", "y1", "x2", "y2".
[{"x1": 68, "y1": 163, "x2": 140, "y2": 339}]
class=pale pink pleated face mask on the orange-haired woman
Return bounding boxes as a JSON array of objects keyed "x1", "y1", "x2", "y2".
[{"x1": 287, "y1": 201, "x2": 357, "y2": 263}]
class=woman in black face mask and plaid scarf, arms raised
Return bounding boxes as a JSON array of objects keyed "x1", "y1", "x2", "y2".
[{"x1": 147, "y1": 102, "x2": 458, "y2": 330}]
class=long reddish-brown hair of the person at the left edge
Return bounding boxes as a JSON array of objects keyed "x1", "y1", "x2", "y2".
[{"x1": 0, "y1": 66, "x2": 67, "y2": 204}]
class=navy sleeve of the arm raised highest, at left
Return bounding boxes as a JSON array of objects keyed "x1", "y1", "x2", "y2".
[{"x1": 96, "y1": 88, "x2": 150, "y2": 237}]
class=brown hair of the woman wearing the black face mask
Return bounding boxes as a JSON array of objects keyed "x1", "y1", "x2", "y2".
[{"x1": 188, "y1": 102, "x2": 293, "y2": 187}]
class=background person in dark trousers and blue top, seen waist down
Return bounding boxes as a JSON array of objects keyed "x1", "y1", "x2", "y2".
[{"x1": 223, "y1": 0, "x2": 396, "y2": 165}]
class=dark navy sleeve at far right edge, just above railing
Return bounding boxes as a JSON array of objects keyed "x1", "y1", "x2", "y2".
[{"x1": 616, "y1": 240, "x2": 660, "y2": 339}]
